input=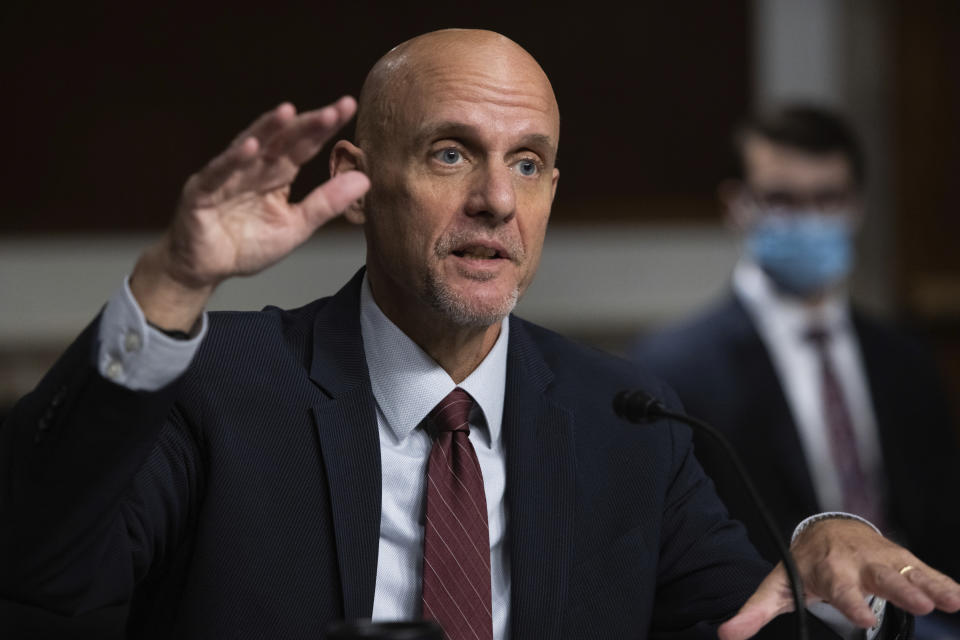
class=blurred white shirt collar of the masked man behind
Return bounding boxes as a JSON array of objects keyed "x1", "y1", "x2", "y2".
[{"x1": 733, "y1": 257, "x2": 850, "y2": 338}]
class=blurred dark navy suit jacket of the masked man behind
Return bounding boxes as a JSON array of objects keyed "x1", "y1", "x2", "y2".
[{"x1": 631, "y1": 295, "x2": 960, "y2": 579}]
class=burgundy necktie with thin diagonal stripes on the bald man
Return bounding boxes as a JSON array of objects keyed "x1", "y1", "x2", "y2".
[{"x1": 423, "y1": 387, "x2": 493, "y2": 640}]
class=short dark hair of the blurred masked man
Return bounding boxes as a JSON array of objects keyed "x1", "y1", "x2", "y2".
[{"x1": 733, "y1": 104, "x2": 866, "y2": 185}]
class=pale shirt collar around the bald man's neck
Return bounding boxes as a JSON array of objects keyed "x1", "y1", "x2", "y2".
[{"x1": 360, "y1": 274, "x2": 510, "y2": 446}]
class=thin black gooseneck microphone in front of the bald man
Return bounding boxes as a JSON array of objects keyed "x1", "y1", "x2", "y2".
[{"x1": 613, "y1": 389, "x2": 807, "y2": 640}]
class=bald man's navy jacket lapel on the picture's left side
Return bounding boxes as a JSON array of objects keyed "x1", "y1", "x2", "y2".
[{"x1": 310, "y1": 270, "x2": 381, "y2": 619}]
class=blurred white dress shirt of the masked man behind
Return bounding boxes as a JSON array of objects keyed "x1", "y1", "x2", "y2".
[{"x1": 733, "y1": 258, "x2": 884, "y2": 511}]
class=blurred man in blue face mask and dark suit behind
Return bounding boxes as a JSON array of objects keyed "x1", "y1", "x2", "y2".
[{"x1": 630, "y1": 105, "x2": 960, "y2": 638}]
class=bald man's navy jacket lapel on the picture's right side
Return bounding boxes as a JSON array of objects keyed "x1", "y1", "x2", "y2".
[{"x1": 503, "y1": 318, "x2": 576, "y2": 638}]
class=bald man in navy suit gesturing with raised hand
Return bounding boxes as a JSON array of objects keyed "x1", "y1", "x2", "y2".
[{"x1": 0, "y1": 30, "x2": 960, "y2": 639}]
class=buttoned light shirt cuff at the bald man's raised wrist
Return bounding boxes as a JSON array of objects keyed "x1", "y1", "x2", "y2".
[{"x1": 97, "y1": 277, "x2": 207, "y2": 391}]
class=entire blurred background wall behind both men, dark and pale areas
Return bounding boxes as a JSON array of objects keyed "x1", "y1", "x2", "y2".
[{"x1": 0, "y1": 0, "x2": 960, "y2": 415}]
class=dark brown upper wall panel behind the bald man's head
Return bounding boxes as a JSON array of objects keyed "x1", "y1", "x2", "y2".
[{"x1": 0, "y1": 0, "x2": 750, "y2": 234}]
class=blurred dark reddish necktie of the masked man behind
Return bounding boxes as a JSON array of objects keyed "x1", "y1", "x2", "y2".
[{"x1": 806, "y1": 328, "x2": 884, "y2": 530}]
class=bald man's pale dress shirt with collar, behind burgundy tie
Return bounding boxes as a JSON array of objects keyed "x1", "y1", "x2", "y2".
[{"x1": 360, "y1": 278, "x2": 510, "y2": 638}]
